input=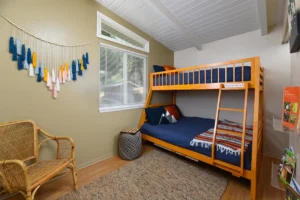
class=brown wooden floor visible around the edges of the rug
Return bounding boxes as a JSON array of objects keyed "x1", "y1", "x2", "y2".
[{"x1": 5, "y1": 144, "x2": 285, "y2": 200}]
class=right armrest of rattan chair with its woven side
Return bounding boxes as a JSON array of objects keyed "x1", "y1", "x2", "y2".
[{"x1": 38, "y1": 129, "x2": 75, "y2": 159}]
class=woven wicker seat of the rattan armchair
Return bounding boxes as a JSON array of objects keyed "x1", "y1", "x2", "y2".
[{"x1": 28, "y1": 159, "x2": 72, "y2": 188}]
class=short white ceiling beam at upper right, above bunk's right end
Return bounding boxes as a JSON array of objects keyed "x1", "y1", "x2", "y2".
[{"x1": 256, "y1": 0, "x2": 268, "y2": 36}]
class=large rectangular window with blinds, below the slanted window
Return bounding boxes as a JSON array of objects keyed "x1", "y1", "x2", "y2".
[{"x1": 99, "y1": 44, "x2": 147, "y2": 112}]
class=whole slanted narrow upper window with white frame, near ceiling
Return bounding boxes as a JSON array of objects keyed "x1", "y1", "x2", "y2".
[{"x1": 97, "y1": 12, "x2": 149, "y2": 53}]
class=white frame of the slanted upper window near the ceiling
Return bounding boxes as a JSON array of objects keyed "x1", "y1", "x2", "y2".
[{"x1": 97, "y1": 11, "x2": 150, "y2": 53}]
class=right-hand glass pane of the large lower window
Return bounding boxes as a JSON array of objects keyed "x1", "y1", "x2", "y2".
[{"x1": 127, "y1": 55, "x2": 145, "y2": 104}]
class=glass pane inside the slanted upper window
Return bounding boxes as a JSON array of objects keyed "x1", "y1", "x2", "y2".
[{"x1": 101, "y1": 22, "x2": 144, "y2": 48}]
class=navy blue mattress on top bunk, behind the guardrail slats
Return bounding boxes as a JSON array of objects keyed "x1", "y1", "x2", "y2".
[{"x1": 153, "y1": 66, "x2": 251, "y2": 86}]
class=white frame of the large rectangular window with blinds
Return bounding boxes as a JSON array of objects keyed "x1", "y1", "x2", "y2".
[{"x1": 99, "y1": 43, "x2": 148, "y2": 113}]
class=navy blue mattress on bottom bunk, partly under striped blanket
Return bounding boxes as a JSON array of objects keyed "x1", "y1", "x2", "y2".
[{"x1": 141, "y1": 117, "x2": 252, "y2": 170}]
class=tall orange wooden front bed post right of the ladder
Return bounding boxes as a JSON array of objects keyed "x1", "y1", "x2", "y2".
[{"x1": 251, "y1": 57, "x2": 260, "y2": 200}]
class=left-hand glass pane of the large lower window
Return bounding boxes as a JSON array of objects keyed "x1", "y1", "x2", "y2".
[{"x1": 100, "y1": 47, "x2": 124, "y2": 106}]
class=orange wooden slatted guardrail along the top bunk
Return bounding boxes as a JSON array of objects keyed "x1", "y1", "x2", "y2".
[{"x1": 150, "y1": 57, "x2": 264, "y2": 90}]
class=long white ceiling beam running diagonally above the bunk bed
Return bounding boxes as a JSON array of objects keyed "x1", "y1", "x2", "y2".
[{"x1": 143, "y1": 0, "x2": 202, "y2": 51}]
